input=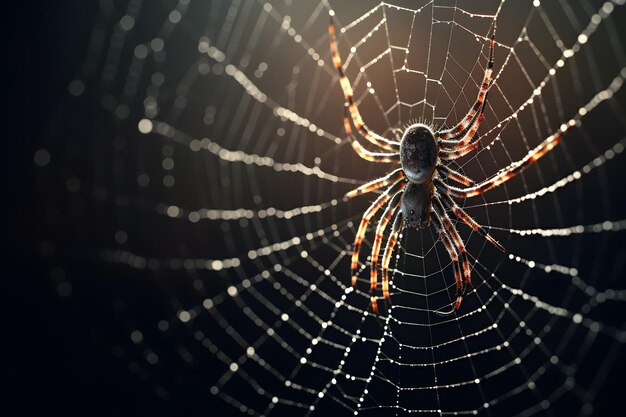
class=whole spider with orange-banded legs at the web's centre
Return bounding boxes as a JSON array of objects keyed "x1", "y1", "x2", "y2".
[{"x1": 329, "y1": 19, "x2": 575, "y2": 315}]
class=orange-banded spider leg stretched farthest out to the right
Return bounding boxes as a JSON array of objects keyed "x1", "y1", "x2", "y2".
[{"x1": 436, "y1": 120, "x2": 576, "y2": 198}]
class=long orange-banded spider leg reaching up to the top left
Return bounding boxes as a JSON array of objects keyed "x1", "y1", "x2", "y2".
[{"x1": 328, "y1": 19, "x2": 400, "y2": 151}]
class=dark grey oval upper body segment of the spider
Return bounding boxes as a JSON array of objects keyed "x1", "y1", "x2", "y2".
[{"x1": 400, "y1": 123, "x2": 437, "y2": 184}]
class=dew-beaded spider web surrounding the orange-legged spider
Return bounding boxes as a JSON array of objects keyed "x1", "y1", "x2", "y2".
[{"x1": 35, "y1": 0, "x2": 626, "y2": 416}]
